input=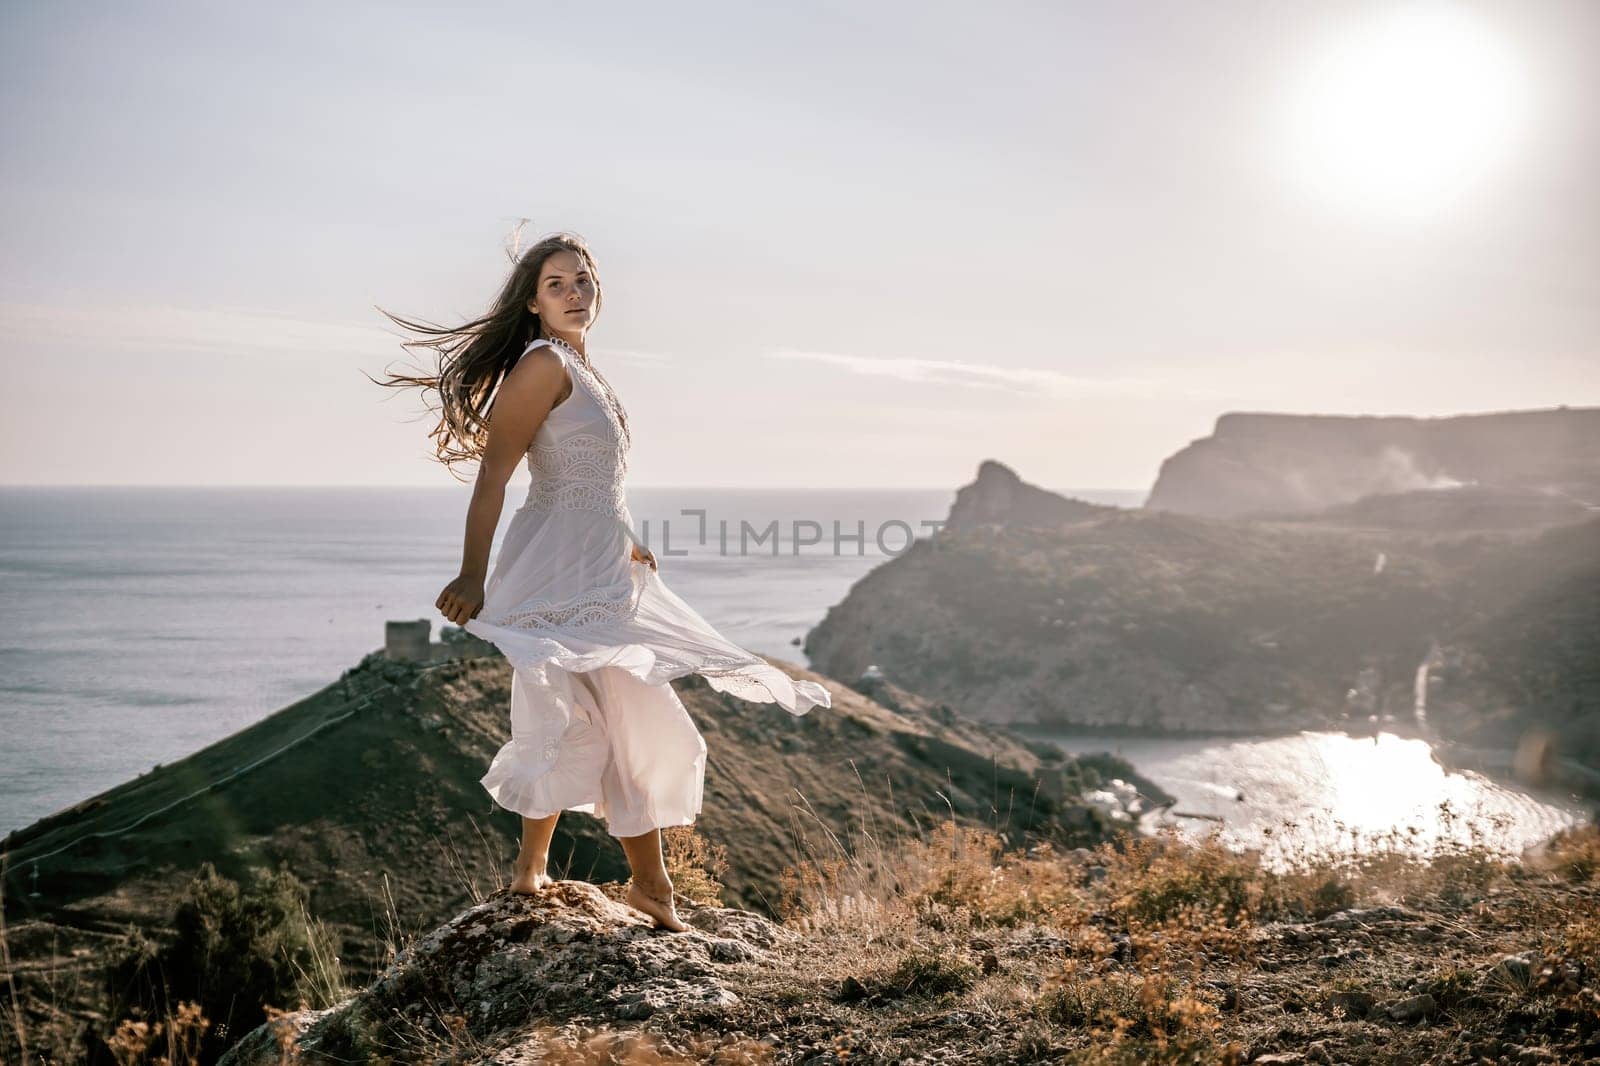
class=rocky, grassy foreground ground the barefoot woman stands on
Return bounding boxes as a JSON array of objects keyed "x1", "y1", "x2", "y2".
[{"x1": 224, "y1": 826, "x2": 1600, "y2": 1064}]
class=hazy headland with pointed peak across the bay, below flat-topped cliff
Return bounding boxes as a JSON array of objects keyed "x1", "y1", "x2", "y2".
[{"x1": 805, "y1": 461, "x2": 1600, "y2": 781}]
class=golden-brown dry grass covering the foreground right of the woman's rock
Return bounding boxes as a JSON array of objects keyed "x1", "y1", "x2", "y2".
[{"x1": 764, "y1": 808, "x2": 1600, "y2": 1063}]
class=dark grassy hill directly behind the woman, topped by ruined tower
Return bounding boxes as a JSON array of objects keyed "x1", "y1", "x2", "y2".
[{"x1": 0, "y1": 623, "x2": 1136, "y2": 1043}]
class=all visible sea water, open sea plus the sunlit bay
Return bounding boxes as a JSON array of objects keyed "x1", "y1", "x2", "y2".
[{"x1": 0, "y1": 482, "x2": 1584, "y2": 845}]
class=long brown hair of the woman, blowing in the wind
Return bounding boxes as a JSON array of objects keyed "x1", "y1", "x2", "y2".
[{"x1": 368, "y1": 224, "x2": 629, "y2": 474}]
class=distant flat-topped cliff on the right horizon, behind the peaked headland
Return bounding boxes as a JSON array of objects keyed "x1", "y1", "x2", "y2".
[{"x1": 1144, "y1": 407, "x2": 1600, "y2": 515}]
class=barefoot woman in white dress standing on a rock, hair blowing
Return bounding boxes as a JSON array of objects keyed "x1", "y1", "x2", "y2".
[{"x1": 369, "y1": 234, "x2": 830, "y2": 932}]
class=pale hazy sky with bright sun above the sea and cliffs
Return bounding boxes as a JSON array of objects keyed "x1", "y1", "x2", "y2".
[{"x1": 0, "y1": 0, "x2": 1600, "y2": 488}]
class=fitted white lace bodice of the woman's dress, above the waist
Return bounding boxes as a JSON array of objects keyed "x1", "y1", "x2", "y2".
[{"x1": 523, "y1": 338, "x2": 629, "y2": 520}]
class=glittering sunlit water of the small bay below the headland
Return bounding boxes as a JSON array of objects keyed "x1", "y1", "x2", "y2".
[{"x1": 1040, "y1": 731, "x2": 1586, "y2": 864}]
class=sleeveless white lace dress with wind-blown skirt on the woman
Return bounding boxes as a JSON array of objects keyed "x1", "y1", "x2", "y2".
[{"x1": 462, "y1": 338, "x2": 832, "y2": 836}]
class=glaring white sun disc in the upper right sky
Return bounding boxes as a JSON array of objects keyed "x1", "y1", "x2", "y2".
[{"x1": 1288, "y1": 2, "x2": 1526, "y2": 218}]
